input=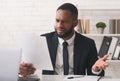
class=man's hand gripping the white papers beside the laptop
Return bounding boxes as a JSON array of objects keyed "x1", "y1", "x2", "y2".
[{"x1": 19, "y1": 63, "x2": 36, "y2": 77}]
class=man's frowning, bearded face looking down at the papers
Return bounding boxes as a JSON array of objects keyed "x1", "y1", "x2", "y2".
[{"x1": 55, "y1": 9, "x2": 76, "y2": 38}]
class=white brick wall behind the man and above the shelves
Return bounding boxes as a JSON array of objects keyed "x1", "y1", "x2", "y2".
[{"x1": 0, "y1": 0, "x2": 120, "y2": 46}]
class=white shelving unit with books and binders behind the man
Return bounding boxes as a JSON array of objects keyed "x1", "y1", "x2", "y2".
[{"x1": 77, "y1": 8, "x2": 120, "y2": 62}]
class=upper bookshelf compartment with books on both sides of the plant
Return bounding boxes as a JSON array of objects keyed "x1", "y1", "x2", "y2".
[{"x1": 78, "y1": 9, "x2": 120, "y2": 34}]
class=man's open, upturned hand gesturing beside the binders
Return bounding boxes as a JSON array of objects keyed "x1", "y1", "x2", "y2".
[{"x1": 92, "y1": 54, "x2": 109, "y2": 72}]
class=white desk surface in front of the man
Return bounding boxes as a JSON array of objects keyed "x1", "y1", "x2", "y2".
[{"x1": 41, "y1": 75, "x2": 120, "y2": 81}]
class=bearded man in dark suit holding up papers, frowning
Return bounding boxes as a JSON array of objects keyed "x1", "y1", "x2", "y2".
[{"x1": 20, "y1": 3, "x2": 108, "y2": 76}]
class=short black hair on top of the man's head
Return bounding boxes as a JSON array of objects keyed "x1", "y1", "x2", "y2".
[{"x1": 57, "y1": 3, "x2": 78, "y2": 19}]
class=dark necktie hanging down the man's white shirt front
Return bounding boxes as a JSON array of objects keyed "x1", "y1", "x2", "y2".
[{"x1": 63, "y1": 42, "x2": 69, "y2": 75}]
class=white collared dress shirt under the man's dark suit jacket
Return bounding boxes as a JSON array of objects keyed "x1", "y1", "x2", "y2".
[{"x1": 55, "y1": 33, "x2": 101, "y2": 75}]
